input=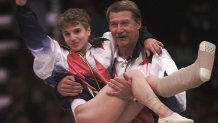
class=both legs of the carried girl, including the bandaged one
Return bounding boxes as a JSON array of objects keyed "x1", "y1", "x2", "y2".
[{"x1": 76, "y1": 42, "x2": 215, "y2": 123}]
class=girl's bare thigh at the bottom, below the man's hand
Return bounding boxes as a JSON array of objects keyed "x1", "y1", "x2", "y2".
[{"x1": 75, "y1": 85, "x2": 130, "y2": 123}]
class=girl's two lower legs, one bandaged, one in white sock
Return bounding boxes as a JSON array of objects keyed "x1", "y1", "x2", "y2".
[{"x1": 110, "y1": 42, "x2": 215, "y2": 123}]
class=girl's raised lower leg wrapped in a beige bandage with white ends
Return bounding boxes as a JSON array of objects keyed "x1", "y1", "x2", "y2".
[{"x1": 147, "y1": 41, "x2": 216, "y2": 97}]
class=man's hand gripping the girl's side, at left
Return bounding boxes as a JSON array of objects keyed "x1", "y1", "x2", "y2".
[{"x1": 57, "y1": 75, "x2": 83, "y2": 96}]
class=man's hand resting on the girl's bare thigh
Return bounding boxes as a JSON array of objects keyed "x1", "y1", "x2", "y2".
[{"x1": 107, "y1": 73, "x2": 132, "y2": 99}]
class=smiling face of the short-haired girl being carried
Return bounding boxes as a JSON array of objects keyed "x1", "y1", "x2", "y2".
[{"x1": 62, "y1": 23, "x2": 91, "y2": 54}]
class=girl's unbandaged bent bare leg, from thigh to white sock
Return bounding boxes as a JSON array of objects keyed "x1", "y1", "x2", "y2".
[{"x1": 75, "y1": 71, "x2": 192, "y2": 123}]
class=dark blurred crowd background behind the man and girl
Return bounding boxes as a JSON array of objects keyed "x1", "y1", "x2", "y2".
[{"x1": 0, "y1": 0, "x2": 218, "y2": 123}]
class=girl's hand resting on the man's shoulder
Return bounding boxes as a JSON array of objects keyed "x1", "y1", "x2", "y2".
[{"x1": 144, "y1": 38, "x2": 164, "y2": 57}]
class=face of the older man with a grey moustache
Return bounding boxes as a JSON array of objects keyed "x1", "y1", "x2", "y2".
[{"x1": 109, "y1": 11, "x2": 141, "y2": 48}]
